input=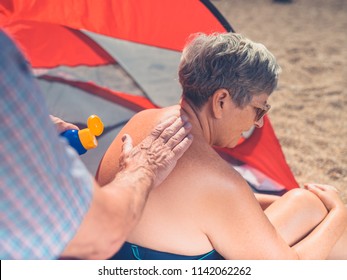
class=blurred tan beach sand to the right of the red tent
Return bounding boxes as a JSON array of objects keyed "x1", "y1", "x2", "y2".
[{"x1": 212, "y1": 0, "x2": 347, "y2": 204}]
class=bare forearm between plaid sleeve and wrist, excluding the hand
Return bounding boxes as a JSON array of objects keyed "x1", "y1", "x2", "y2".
[{"x1": 62, "y1": 171, "x2": 153, "y2": 259}]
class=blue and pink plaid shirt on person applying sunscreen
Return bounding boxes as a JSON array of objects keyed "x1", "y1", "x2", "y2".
[{"x1": 0, "y1": 30, "x2": 92, "y2": 259}]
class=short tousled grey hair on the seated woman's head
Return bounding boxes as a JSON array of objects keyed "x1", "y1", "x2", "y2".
[{"x1": 178, "y1": 33, "x2": 280, "y2": 108}]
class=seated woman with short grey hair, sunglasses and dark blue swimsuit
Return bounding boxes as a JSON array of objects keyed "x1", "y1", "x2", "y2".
[{"x1": 98, "y1": 33, "x2": 347, "y2": 259}]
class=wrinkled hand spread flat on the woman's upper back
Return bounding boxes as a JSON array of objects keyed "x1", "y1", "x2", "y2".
[{"x1": 119, "y1": 116, "x2": 193, "y2": 187}]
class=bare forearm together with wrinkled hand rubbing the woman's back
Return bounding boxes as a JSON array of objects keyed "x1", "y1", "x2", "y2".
[{"x1": 63, "y1": 116, "x2": 193, "y2": 259}]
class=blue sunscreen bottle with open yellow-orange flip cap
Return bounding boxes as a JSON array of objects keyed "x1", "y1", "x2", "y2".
[{"x1": 60, "y1": 115, "x2": 104, "y2": 155}]
